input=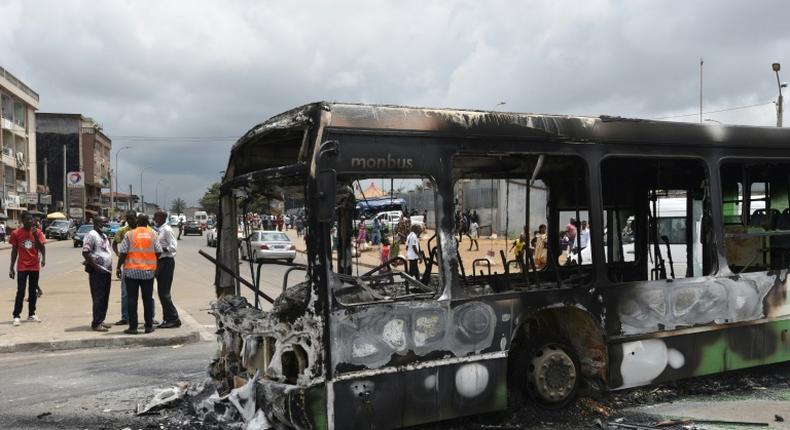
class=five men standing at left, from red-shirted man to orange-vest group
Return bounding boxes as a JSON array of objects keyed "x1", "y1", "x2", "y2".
[{"x1": 9, "y1": 211, "x2": 181, "y2": 334}]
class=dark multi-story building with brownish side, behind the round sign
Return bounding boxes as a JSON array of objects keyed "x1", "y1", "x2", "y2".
[{"x1": 36, "y1": 113, "x2": 112, "y2": 219}]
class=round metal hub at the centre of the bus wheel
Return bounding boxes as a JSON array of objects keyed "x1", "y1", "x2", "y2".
[{"x1": 532, "y1": 345, "x2": 576, "y2": 402}]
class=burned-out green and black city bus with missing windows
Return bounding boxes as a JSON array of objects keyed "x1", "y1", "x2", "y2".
[{"x1": 211, "y1": 103, "x2": 790, "y2": 429}]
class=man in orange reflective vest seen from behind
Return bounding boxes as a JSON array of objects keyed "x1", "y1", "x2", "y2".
[{"x1": 117, "y1": 214, "x2": 162, "y2": 334}]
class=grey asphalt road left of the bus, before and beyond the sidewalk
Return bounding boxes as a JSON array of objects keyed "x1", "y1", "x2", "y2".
[{"x1": 0, "y1": 228, "x2": 304, "y2": 430}]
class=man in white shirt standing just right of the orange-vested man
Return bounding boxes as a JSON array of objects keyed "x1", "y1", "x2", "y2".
[{"x1": 154, "y1": 211, "x2": 181, "y2": 328}]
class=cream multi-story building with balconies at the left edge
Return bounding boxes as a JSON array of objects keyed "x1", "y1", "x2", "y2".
[{"x1": 0, "y1": 67, "x2": 39, "y2": 228}]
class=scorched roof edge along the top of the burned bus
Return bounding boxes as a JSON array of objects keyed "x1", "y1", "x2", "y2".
[{"x1": 234, "y1": 102, "x2": 790, "y2": 152}]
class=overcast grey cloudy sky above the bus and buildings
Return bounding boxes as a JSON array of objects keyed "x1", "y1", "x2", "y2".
[{"x1": 0, "y1": 0, "x2": 790, "y2": 205}]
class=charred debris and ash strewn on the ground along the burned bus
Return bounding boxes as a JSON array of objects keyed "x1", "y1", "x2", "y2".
[{"x1": 125, "y1": 354, "x2": 790, "y2": 430}]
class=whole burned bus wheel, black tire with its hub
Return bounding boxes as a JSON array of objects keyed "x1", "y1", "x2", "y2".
[{"x1": 512, "y1": 333, "x2": 582, "y2": 409}]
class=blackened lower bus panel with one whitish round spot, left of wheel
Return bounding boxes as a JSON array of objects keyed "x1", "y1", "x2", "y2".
[{"x1": 334, "y1": 358, "x2": 507, "y2": 429}]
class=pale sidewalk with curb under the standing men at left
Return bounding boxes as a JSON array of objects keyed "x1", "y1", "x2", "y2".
[{"x1": 0, "y1": 242, "x2": 205, "y2": 353}]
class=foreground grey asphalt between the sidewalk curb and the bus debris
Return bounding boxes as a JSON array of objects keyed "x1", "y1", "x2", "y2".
[{"x1": 0, "y1": 342, "x2": 215, "y2": 430}]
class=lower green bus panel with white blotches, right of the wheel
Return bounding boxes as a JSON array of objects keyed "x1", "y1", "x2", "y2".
[{"x1": 609, "y1": 319, "x2": 790, "y2": 389}]
